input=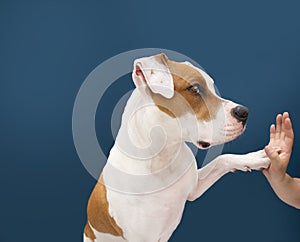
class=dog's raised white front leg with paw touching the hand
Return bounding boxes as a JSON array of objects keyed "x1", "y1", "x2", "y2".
[{"x1": 188, "y1": 150, "x2": 270, "y2": 201}]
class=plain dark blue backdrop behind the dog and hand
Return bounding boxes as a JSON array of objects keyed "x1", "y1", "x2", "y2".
[{"x1": 0, "y1": 0, "x2": 300, "y2": 242}]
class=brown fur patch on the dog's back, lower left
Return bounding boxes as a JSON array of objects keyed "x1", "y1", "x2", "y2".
[{"x1": 85, "y1": 174, "x2": 123, "y2": 240}]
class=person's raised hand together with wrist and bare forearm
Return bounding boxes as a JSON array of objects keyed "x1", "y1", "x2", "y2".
[{"x1": 263, "y1": 112, "x2": 300, "y2": 208}]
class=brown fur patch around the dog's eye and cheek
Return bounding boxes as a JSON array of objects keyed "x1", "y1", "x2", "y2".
[{"x1": 151, "y1": 60, "x2": 221, "y2": 121}]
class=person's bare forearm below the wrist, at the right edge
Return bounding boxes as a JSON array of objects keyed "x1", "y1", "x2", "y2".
[{"x1": 267, "y1": 173, "x2": 300, "y2": 209}]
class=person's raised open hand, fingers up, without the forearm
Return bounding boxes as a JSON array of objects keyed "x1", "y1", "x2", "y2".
[{"x1": 263, "y1": 112, "x2": 294, "y2": 182}]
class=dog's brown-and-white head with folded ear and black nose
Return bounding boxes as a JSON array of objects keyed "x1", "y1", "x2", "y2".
[{"x1": 132, "y1": 54, "x2": 248, "y2": 149}]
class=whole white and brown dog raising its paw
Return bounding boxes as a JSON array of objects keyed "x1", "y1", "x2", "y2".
[{"x1": 83, "y1": 53, "x2": 270, "y2": 242}]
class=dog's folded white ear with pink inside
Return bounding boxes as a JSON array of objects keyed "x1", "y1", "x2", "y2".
[{"x1": 132, "y1": 53, "x2": 174, "y2": 98}]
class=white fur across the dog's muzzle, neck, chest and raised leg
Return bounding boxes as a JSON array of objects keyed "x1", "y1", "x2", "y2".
[{"x1": 85, "y1": 57, "x2": 269, "y2": 242}]
